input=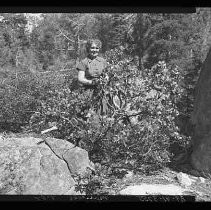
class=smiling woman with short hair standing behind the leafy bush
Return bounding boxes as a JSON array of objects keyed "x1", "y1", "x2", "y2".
[{"x1": 76, "y1": 39, "x2": 107, "y2": 115}]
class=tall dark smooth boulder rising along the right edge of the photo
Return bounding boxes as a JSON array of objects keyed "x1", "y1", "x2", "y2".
[{"x1": 191, "y1": 50, "x2": 211, "y2": 173}]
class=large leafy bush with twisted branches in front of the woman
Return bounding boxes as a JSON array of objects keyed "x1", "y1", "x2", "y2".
[{"x1": 30, "y1": 50, "x2": 189, "y2": 171}]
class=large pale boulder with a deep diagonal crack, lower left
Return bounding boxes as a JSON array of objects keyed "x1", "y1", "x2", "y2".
[{"x1": 0, "y1": 137, "x2": 93, "y2": 195}]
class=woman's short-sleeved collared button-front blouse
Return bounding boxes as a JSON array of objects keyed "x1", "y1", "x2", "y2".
[{"x1": 76, "y1": 56, "x2": 107, "y2": 79}]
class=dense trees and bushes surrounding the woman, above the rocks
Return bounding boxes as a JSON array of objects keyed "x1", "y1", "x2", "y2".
[{"x1": 0, "y1": 8, "x2": 211, "y2": 170}]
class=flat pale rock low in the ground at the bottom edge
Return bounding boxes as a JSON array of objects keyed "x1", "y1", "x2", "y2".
[{"x1": 119, "y1": 184, "x2": 185, "y2": 195}]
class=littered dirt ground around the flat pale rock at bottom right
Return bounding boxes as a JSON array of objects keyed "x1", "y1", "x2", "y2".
[{"x1": 96, "y1": 168, "x2": 211, "y2": 202}]
